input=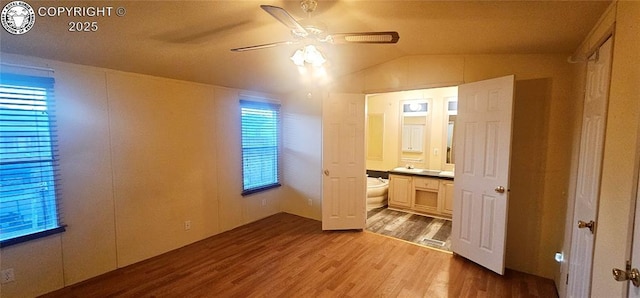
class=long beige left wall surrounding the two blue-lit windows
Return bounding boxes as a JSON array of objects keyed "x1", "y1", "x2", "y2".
[{"x1": 0, "y1": 54, "x2": 282, "y2": 297}]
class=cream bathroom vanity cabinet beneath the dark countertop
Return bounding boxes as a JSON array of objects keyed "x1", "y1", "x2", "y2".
[{"x1": 389, "y1": 174, "x2": 453, "y2": 219}]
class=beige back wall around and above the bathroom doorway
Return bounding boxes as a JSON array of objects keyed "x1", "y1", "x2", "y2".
[{"x1": 284, "y1": 54, "x2": 573, "y2": 278}]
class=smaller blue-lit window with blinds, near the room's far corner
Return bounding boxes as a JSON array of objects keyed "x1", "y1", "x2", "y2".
[{"x1": 240, "y1": 100, "x2": 280, "y2": 195}]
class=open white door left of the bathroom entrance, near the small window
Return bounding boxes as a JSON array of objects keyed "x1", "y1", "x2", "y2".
[{"x1": 322, "y1": 94, "x2": 367, "y2": 230}]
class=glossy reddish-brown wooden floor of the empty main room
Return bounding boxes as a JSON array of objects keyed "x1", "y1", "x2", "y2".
[{"x1": 44, "y1": 213, "x2": 557, "y2": 297}]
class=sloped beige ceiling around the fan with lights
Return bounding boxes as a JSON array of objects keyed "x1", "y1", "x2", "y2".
[{"x1": 0, "y1": 0, "x2": 610, "y2": 93}]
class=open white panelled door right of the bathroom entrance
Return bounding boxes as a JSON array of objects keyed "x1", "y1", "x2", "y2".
[{"x1": 451, "y1": 75, "x2": 514, "y2": 274}]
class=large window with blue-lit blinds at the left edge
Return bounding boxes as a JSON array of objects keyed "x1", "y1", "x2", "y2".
[{"x1": 0, "y1": 73, "x2": 64, "y2": 246}]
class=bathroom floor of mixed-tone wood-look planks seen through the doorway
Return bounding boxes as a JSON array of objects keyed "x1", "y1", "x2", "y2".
[{"x1": 366, "y1": 207, "x2": 451, "y2": 251}]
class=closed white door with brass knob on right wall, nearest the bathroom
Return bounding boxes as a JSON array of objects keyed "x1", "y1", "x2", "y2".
[{"x1": 567, "y1": 39, "x2": 612, "y2": 297}]
